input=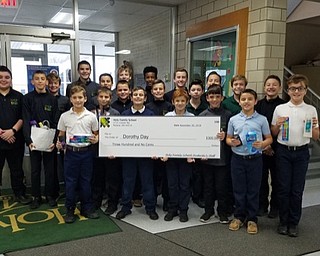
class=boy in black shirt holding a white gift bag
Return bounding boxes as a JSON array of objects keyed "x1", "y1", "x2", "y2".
[{"x1": 22, "y1": 70, "x2": 60, "y2": 209}]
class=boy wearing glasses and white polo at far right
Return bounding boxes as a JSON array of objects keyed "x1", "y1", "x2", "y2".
[{"x1": 271, "y1": 74, "x2": 319, "y2": 237}]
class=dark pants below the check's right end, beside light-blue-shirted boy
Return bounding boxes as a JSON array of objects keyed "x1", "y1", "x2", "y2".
[{"x1": 203, "y1": 164, "x2": 228, "y2": 216}]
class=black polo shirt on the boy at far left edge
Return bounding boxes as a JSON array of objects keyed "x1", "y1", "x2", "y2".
[{"x1": 0, "y1": 88, "x2": 24, "y2": 150}]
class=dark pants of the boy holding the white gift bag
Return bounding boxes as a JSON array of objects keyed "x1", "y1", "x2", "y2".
[{"x1": 29, "y1": 150, "x2": 58, "y2": 198}]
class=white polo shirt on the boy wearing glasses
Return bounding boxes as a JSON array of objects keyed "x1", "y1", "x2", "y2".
[{"x1": 271, "y1": 101, "x2": 318, "y2": 147}]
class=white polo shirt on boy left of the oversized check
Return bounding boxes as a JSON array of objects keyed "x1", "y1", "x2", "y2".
[{"x1": 58, "y1": 108, "x2": 99, "y2": 147}]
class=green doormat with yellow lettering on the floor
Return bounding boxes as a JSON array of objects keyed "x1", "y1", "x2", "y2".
[{"x1": 0, "y1": 191, "x2": 121, "y2": 253}]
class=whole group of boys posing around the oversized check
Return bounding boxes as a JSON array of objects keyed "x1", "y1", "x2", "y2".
[{"x1": 0, "y1": 61, "x2": 319, "y2": 237}]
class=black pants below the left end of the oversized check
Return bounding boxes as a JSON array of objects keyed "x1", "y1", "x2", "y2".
[{"x1": 92, "y1": 157, "x2": 122, "y2": 207}]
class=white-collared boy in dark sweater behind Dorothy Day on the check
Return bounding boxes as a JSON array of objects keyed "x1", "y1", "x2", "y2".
[{"x1": 116, "y1": 86, "x2": 159, "y2": 220}]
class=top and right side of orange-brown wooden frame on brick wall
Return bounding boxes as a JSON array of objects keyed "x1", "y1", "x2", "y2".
[{"x1": 186, "y1": 8, "x2": 249, "y2": 75}]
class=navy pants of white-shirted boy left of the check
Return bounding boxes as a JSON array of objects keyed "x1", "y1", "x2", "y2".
[{"x1": 64, "y1": 150, "x2": 93, "y2": 212}]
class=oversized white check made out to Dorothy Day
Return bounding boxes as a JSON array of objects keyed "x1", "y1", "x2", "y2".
[{"x1": 99, "y1": 116, "x2": 220, "y2": 158}]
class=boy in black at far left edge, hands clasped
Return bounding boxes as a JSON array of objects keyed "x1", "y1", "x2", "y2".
[{"x1": 0, "y1": 66, "x2": 32, "y2": 204}]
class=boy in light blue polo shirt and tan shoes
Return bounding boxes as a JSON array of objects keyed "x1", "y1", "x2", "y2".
[{"x1": 226, "y1": 89, "x2": 272, "y2": 234}]
